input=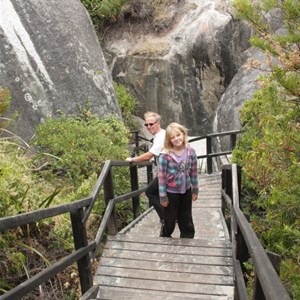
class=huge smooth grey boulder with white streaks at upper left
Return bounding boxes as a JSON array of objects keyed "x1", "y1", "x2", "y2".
[{"x1": 0, "y1": 0, "x2": 120, "y2": 141}]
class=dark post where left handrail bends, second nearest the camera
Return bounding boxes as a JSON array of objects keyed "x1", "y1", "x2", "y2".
[{"x1": 103, "y1": 169, "x2": 118, "y2": 235}]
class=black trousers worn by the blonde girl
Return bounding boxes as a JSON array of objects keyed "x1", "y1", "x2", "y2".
[{"x1": 160, "y1": 189, "x2": 195, "y2": 238}]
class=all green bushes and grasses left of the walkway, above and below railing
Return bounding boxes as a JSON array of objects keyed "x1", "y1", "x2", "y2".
[{"x1": 0, "y1": 86, "x2": 139, "y2": 299}]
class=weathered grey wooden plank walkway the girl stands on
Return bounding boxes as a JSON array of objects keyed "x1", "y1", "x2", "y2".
[{"x1": 94, "y1": 174, "x2": 234, "y2": 300}]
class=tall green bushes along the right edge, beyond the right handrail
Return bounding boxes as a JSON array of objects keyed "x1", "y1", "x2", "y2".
[{"x1": 232, "y1": 0, "x2": 300, "y2": 299}]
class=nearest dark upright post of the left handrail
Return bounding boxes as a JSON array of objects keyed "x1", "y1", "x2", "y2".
[{"x1": 70, "y1": 208, "x2": 93, "y2": 295}]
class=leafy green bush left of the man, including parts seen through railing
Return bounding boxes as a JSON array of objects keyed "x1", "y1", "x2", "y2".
[{"x1": 34, "y1": 106, "x2": 135, "y2": 244}]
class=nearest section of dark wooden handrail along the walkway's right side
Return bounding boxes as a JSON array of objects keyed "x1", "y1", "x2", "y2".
[{"x1": 222, "y1": 164, "x2": 290, "y2": 300}]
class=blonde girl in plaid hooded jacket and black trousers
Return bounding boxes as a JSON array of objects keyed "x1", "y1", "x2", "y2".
[{"x1": 158, "y1": 123, "x2": 198, "y2": 238}]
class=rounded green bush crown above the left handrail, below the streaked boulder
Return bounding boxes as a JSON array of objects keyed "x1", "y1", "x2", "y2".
[{"x1": 34, "y1": 108, "x2": 128, "y2": 186}]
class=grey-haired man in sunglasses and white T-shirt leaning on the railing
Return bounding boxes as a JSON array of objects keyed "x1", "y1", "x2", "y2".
[{"x1": 126, "y1": 111, "x2": 166, "y2": 222}]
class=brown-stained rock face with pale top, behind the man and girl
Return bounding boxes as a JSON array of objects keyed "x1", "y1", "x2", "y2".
[{"x1": 103, "y1": 0, "x2": 250, "y2": 135}]
